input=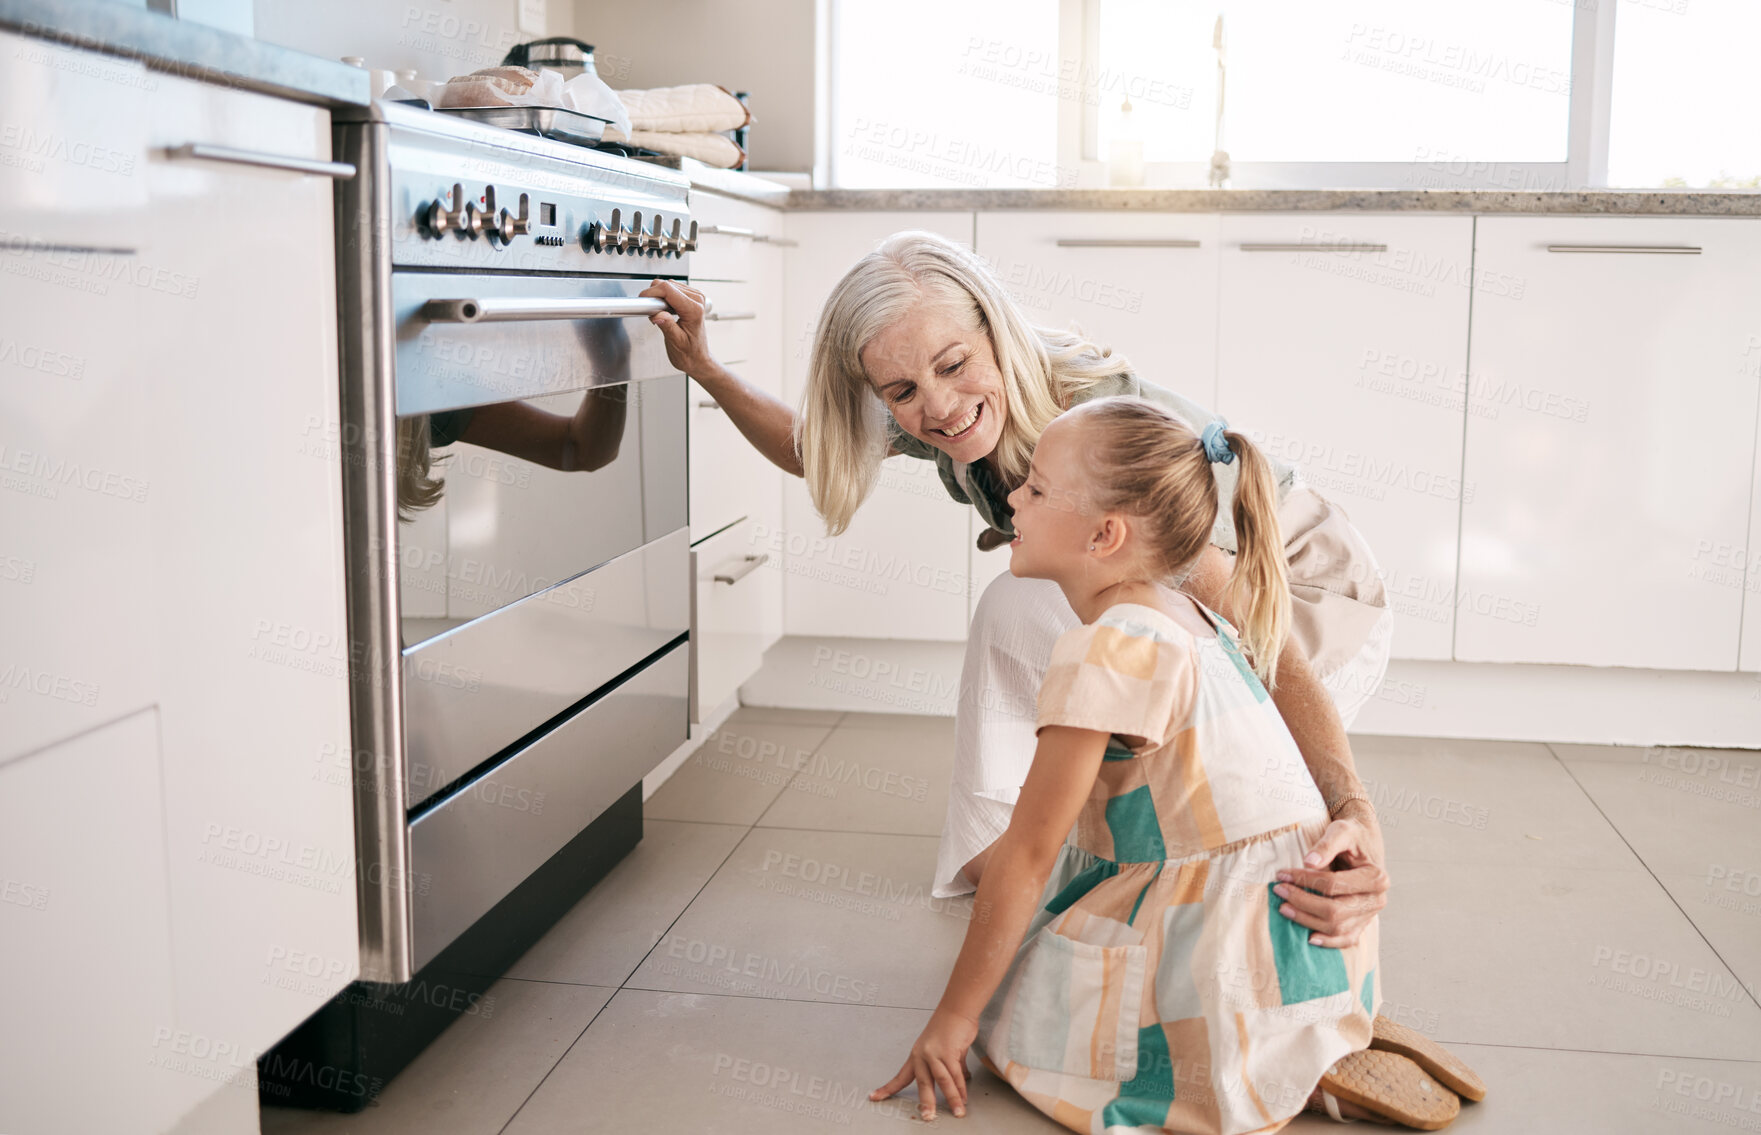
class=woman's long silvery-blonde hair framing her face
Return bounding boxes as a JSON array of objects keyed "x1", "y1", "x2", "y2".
[{"x1": 794, "y1": 231, "x2": 1131, "y2": 535}]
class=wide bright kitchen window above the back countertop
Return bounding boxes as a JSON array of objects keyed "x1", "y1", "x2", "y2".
[{"x1": 821, "y1": 0, "x2": 1761, "y2": 190}]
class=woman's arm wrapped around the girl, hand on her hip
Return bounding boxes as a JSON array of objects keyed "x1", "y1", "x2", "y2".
[{"x1": 1185, "y1": 547, "x2": 1389, "y2": 947}]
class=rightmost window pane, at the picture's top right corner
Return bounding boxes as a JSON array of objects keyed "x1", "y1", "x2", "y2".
[{"x1": 1608, "y1": 0, "x2": 1761, "y2": 188}]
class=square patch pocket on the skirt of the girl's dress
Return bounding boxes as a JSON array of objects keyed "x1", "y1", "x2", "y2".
[{"x1": 1009, "y1": 926, "x2": 1148, "y2": 1080}]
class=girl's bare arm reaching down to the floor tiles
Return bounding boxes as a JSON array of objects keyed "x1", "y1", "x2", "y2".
[{"x1": 868, "y1": 725, "x2": 1108, "y2": 1119}]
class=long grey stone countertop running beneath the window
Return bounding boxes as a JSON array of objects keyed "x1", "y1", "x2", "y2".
[{"x1": 650, "y1": 172, "x2": 1761, "y2": 216}]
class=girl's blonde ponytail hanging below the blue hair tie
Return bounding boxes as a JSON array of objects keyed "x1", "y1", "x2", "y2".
[{"x1": 1222, "y1": 429, "x2": 1291, "y2": 690}]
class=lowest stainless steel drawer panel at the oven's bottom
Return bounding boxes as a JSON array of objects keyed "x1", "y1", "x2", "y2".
[{"x1": 409, "y1": 642, "x2": 690, "y2": 968}]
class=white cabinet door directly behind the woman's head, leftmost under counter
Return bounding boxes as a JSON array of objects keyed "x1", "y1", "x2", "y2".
[{"x1": 785, "y1": 211, "x2": 972, "y2": 642}]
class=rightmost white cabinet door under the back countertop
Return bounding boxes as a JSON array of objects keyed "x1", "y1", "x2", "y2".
[{"x1": 1456, "y1": 216, "x2": 1761, "y2": 670}]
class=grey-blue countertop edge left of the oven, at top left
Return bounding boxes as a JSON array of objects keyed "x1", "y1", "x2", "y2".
[{"x1": 0, "y1": 0, "x2": 370, "y2": 107}]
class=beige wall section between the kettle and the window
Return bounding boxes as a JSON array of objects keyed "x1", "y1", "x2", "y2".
[{"x1": 570, "y1": 0, "x2": 814, "y2": 171}]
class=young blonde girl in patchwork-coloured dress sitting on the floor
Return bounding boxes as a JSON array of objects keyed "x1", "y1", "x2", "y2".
[{"x1": 872, "y1": 398, "x2": 1470, "y2": 1133}]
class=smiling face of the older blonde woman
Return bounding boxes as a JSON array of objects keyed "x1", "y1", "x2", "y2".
[{"x1": 861, "y1": 301, "x2": 1007, "y2": 465}]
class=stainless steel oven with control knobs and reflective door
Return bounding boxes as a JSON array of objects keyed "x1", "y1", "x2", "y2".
[{"x1": 336, "y1": 104, "x2": 696, "y2": 982}]
